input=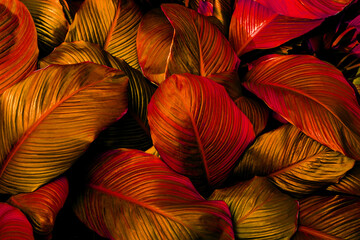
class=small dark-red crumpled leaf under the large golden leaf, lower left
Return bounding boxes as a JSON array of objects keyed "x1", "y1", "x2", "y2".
[{"x1": 7, "y1": 177, "x2": 69, "y2": 235}]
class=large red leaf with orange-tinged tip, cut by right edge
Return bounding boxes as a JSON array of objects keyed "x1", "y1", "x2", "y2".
[{"x1": 243, "y1": 55, "x2": 360, "y2": 160}]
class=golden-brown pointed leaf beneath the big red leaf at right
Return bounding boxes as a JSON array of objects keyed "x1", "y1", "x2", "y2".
[{"x1": 234, "y1": 124, "x2": 355, "y2": 196}]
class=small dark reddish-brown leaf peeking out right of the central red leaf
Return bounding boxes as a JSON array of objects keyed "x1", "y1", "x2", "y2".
[{"x1": 235, "y1": 96, "x2": 269, "y2": 135}]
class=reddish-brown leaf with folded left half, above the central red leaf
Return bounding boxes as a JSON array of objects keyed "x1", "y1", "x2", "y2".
[{"x1": 137, "y1": 4, "x2": 240, "y2": 84}]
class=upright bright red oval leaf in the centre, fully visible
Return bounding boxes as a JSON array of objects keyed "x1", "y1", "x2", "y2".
[{"x1": 148, "y1": 74, "x2": 255, "y2": 194}]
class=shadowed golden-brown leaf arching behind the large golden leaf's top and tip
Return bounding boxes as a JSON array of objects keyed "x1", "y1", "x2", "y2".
[{"x1": 39, "y1": 41, "x2": 156, "y2": 150}]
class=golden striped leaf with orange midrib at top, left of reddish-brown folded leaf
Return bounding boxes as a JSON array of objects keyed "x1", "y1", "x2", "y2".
[{"x1": 65, "y1": 0, "x2": 142, "y2": 69}]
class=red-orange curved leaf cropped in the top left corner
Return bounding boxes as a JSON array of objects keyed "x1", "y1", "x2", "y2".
[{"x1": 0, "y1": 0, "x2": 39, "y2": 94}]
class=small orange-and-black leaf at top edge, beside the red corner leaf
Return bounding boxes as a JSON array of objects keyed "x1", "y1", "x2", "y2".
[{"x1": 21, "y1": 0, "x2": 69, "y2": 56}]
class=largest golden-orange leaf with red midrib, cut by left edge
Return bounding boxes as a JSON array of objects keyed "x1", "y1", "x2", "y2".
[{"x1": 0, "y1": 63, "x2": 128, "y2": 194}]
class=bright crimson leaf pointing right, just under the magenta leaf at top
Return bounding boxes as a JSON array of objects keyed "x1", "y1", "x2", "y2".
[{"x1": 229, "y1": 0, "x2": 323, "y2": 56}]
